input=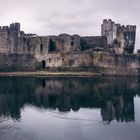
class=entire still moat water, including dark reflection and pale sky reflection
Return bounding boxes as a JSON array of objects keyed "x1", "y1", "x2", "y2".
[{"x1": 0, "y1": 77, "x2": 140, "y2": 140}]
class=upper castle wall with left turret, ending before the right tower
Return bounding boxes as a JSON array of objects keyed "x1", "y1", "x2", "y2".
[{"x1": 0, "y1": 23, "x2": 107, "y2": 55}]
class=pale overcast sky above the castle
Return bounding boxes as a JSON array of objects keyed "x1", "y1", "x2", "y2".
[{"x1": 0, "y1": 0, "x2": 140, "y2": 48}]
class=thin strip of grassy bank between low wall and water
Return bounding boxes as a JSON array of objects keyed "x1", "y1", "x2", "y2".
[{"x1": 0, "y1": 71, "x2": 102, "y2": 77}]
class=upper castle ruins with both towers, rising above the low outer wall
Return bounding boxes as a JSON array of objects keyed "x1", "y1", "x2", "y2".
[{"x1": 0, "y1": 19, "x2": 136, "y2": 55}]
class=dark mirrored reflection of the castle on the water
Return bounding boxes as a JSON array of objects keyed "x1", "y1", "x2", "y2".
[{"x1": 0, "y1": 77, "x2": 140, "y2": 122}]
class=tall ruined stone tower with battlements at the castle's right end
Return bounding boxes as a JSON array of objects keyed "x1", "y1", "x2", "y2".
[{"x1": 101, "y1": 19, "x2": 136, "y2": 54}]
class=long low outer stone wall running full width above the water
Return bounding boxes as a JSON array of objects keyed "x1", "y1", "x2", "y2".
[{"x1": 0, "y1": 52, "x2": 140, "y2": 75}]
